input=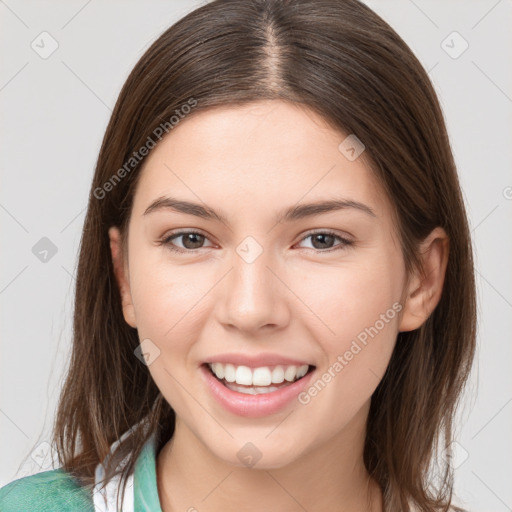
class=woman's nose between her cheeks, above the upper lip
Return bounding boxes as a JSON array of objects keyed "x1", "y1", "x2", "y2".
[{"x1": 217, "y1": 247, "x2": 292, "y2": 334}]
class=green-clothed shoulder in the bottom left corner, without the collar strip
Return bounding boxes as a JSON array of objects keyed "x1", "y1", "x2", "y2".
[{"x1": 0, "y1": 468, "x2": 94, "y2": 512}]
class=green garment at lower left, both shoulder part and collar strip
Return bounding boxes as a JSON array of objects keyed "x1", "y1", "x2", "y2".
[{"x1": 0, "y1": 435, "x2": 162, "y2": 512}]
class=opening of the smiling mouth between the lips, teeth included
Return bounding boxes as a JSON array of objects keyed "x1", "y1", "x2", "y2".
[{"x1": 202, "y1": 363, "x2": 316, "y2": 395}]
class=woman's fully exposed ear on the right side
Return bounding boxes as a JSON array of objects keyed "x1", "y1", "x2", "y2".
[{"x1": 399, "y1": 227, "x2": 449, "y2": 331}]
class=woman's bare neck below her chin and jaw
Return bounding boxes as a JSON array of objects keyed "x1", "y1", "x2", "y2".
[{"x1": 157, "y1": 408, "x2": 382, "y2": 512}]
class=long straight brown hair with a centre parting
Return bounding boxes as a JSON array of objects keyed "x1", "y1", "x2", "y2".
[{"x1": 54, "y1": 0, "x2": 476, "y2": 512}]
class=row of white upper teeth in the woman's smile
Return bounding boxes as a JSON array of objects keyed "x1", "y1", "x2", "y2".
[{"x1": 208, "y1": 363, "x2": 309, "y2": 386}]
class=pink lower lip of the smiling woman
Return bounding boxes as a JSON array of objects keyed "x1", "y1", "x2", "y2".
[{"x1": 200, "y1": 365, "x2": 314, "y2": 418}]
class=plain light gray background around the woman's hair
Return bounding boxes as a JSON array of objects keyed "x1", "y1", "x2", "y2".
[{"x1": 0, "y1": 0, "x2": 512, "y2": 512}]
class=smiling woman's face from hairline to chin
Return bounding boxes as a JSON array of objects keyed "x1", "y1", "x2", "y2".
[{"x1": 110, "y1": 101, "x2": 412, "y2": 468}]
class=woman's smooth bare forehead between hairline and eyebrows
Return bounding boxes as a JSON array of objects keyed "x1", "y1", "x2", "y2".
[{"x1": 134, "y1": 100, "x2": 388, "y2": 218}]
